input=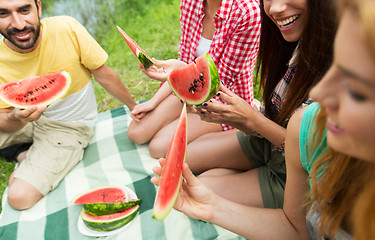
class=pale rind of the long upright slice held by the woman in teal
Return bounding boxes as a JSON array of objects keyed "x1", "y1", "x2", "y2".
[{"x1": 152, "y1": 103, "x2": 188, "y2": 221}]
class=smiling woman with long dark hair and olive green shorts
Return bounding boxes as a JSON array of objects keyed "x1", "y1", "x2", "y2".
[{"x1": 186, "y1": 0, "x2": 337, "y2": 208}]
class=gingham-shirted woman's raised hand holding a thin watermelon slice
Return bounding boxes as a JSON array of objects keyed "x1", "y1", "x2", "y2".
[{"x1": 138, "y1": 58, "x2": 187, "y2": 82}]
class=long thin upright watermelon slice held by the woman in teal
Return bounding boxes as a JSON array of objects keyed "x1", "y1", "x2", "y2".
[{"x1": 152, "y1": 104, "x2": 187, "y2": 221}]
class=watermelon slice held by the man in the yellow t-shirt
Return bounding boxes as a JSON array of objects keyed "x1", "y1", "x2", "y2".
[{"x1": 0, "y1": 71, "x2": 72, "y2": 108}]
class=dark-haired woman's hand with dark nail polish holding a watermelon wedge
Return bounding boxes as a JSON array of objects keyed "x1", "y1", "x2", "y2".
[{"x1": 190, "y1": 84, "x2": 259, "y2": 133}]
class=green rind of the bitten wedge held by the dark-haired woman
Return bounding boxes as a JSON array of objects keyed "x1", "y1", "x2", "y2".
[{"x1": 168, "y1": 52, "x2": 220, "y2": 105}]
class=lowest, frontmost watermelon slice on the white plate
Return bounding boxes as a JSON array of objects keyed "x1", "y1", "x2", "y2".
[{"x1": 81, "y1": 205, "x2": 139, "y2": 232}]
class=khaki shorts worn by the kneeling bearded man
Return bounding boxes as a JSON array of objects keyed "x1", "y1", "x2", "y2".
[{"x1": 0, "y1": 116, "x2": 93, "y2": 196}]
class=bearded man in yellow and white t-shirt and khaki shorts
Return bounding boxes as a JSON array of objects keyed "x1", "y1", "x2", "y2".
[{"x1": 0, "y1": 0, "x2": 135, "y2": 210}]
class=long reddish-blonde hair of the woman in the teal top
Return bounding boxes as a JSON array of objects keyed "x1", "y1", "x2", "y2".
[{"x1": 307, "y1": 0, "x2": 375, "y2": 240}]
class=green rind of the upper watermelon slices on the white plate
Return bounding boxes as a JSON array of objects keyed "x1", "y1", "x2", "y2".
[{"x1": 83, "y1": 199, "x2": 142, "y2": 216}]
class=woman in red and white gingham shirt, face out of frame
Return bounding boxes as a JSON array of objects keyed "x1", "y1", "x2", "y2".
[{"x1": 128, "y1": 0, "x2": 260, "y2": 158}]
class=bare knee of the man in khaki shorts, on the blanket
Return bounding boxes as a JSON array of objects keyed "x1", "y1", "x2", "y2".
[{"x1": 8, "y1": 183, "x2": 43, "y2": 210}]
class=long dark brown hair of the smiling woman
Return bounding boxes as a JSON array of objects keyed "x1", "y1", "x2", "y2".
[{"x1": 256, "y1": 0, "x2": 337, "y2": 127}]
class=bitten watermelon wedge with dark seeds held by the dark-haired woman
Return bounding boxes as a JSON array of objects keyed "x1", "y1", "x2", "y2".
[{"x1": 168, "y1": 53, "x2": 220, "y2": 105}]
